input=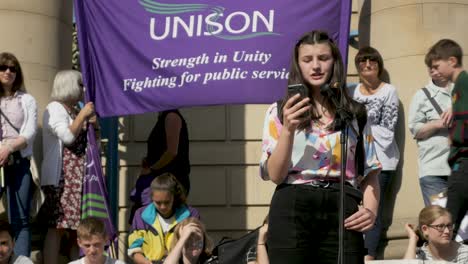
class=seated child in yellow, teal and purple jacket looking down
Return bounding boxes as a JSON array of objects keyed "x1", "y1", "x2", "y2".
[{"x1": 128, "y1": 173, "x2": 199, "y2": 264}]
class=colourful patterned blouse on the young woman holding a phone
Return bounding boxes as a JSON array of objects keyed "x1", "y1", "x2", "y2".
[{"x1": 260, "y1": 103, "x2": 382, "y2": 187}]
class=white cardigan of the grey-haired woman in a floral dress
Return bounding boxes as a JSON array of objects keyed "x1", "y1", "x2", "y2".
[{"x1": 41, "y1": 101, "x2": 75, "y2": 186}]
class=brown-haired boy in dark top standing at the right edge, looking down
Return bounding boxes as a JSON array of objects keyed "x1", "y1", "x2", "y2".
[{"x1": 428, "y1": 39, "x2": 468, "y2": 234}]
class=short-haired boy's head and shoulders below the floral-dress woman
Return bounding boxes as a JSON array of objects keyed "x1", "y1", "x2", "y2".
[{"x1": 69, "y1": 217, "x2": 125, "y2": 264}]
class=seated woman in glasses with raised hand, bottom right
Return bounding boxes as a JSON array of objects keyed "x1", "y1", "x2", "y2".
[{"x1": 404, "y1": 205, "x2": 468, "y2": 263}]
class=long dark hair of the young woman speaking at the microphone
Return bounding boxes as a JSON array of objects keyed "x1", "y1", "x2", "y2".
[{"x1": 284, "y1": 30, "x2": 365, "y2": 130}]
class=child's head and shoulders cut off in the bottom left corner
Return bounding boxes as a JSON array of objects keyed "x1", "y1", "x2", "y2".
[{"x1": 0, "y1": 220, "x2": 33, "y2": 264}]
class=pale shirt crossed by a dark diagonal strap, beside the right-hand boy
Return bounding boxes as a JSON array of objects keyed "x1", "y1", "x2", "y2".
[{"x1": 408, "y1": 80, "x2": 453, "y2": 177}]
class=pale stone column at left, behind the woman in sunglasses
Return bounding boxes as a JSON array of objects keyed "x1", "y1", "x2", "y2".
[{"x1": 0, "y1": 0, "x2": 73, "y2": 159}]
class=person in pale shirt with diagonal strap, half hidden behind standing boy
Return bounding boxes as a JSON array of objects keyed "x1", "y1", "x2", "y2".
[{"x1": 408, "y1": 54, "x2": 453, "y2": 206}]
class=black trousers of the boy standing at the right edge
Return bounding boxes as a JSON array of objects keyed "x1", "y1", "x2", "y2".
[{"x1": 447, "y1": 160, "x2": 468, "y2": 235}]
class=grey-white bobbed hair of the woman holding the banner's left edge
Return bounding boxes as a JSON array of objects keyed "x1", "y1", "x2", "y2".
[{"x1": 50, "y1": 70, "x2": 83, "y2": 103}]
